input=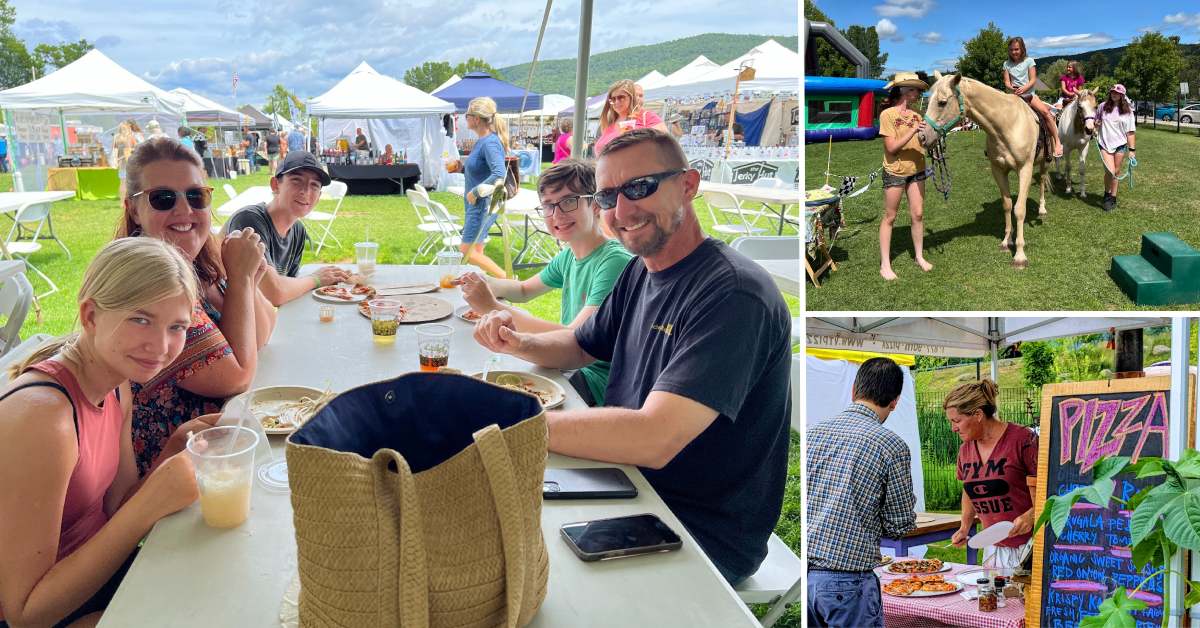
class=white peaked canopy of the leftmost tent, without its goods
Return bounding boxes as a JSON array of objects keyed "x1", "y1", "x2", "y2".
[{"x1": 0, "y1": 49, "x2": 184, "y2": 191}]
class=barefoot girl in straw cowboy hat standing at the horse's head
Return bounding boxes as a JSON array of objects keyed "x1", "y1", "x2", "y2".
[{"x1": 880, "y1": 72, "x2": 934, "y2": 281}]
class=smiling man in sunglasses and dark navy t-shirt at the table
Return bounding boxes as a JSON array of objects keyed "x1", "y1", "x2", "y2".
[{"x1": 475, "y1": 128, "x2": 792, "y2": 584}]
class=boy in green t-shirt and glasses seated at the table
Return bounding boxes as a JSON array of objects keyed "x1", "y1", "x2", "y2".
[{"x1": 461, "y1": 159, "x2": 632, "y2": 406}]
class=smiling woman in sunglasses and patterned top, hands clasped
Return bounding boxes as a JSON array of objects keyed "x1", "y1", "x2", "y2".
[{"x1": 116, "y1": 138, "x2": 275, "y2": 474}]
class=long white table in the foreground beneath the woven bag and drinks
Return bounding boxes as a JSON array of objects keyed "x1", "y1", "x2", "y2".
[{"x1": 100, "y1": 265, "x2": 758, "y2": 628}]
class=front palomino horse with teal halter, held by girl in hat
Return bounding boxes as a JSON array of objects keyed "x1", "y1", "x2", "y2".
[{"x1": 920, "y1": 72, "x2": 1050, "y2": 268}]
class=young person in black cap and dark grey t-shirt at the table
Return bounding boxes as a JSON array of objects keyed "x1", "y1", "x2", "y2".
[{"x1": 224, "y1": 150, "x2": 349, "y2": 305}]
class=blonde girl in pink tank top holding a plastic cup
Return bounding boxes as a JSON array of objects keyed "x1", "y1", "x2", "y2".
[{"x1": 0, "y1": 238, "x2": 212, "y2": 626}]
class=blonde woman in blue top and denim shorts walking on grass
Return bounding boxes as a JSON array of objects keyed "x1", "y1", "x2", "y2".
[{"x1": 458, "y1": 96, "x2": 509, "y2": 279}]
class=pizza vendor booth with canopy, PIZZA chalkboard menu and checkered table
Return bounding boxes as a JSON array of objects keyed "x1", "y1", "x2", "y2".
[{"x1": 806, "y1": 316, "x2": 1200, "y2": 627}]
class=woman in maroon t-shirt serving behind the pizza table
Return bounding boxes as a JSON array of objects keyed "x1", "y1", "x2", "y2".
[{"x1": 942, "y1": 379, "x2": 1038, "y2": 567}]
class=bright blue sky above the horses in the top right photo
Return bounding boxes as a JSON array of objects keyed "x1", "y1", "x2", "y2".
[{"x1": 815, "y1": 0, "x2": 1200, "y2": 74}]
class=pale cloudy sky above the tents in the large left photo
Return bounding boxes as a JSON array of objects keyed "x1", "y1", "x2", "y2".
[{"x1": 10, "y1": 0, "x2": 799, "y2": 104}]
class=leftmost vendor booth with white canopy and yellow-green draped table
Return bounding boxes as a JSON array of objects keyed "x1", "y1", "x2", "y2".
[{"x1": 0, "y1": 49, "x2": 184, "y2": 198}]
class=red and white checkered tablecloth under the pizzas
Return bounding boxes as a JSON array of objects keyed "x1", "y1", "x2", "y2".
[{"x1": 876, "y1": 563, "x2": 1025, "y2": 628}]
